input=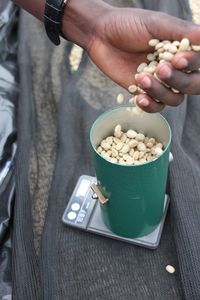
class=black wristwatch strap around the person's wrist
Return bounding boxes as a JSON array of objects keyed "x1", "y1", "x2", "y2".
[{"x1": 44, "y1": 0, "x2": 68, "y2": 45}]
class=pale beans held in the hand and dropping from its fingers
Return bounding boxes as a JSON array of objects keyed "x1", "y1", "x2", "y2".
[{"x1": 116, "y1": 38, "x2": 200, "y2": 114}]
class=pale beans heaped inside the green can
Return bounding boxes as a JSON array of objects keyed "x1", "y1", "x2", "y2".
[{"x1": 97, "y1": 125, "x2": 164, "y2": 165}]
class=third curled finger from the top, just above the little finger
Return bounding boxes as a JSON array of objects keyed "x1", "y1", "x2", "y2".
[{"x1": 135, "y1": 73, "x2": 184, "y2": 106}]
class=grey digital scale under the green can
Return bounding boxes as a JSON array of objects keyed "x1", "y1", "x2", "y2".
[{"x1": 62, "y1": 175, "x2": 169, "y2": 249}]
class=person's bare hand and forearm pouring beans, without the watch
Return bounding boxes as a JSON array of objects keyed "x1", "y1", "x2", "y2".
[{"x1": 15, "y1": 0, "x2": 200, "y2": 112}]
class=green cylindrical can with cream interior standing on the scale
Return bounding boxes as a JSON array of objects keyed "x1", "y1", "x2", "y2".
[{"x1": 90, "y1": 106, "x2": 171, "y2": 238}]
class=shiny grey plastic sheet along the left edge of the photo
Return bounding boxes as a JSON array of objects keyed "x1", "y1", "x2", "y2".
[{"x1": 0, "y1": 0, "x2": 18, "y2": 300}]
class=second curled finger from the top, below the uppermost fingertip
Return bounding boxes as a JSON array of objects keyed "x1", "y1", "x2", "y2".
[{"x1": 156, "y1": 63, "x2": 200, "y2": 95}]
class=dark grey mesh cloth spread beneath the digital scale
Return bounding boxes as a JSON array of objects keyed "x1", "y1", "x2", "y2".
[{"x1": 12, "y1": 0, "x2": 200, "y2": 300}]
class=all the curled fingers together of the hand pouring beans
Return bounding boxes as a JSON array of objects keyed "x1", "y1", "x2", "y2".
[{"x1": 132, "y1": 55, "x2": 200, "y2": 112}]
